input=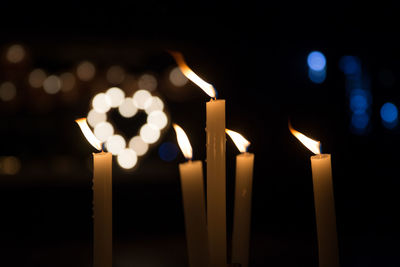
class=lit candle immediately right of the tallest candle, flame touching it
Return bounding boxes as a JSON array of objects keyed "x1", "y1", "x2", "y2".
[{"x1": 226, "y1": 129, "x2": 254, "y2": 267}]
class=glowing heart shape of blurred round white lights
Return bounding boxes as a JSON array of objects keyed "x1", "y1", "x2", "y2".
[{"x1": 87, "y1": 87, "x2": 169, "y2": 169}]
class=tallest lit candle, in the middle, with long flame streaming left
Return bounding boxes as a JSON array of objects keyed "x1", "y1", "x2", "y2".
[{"x1": 170, "y1": 52, "x2": 227, "y2": 267}]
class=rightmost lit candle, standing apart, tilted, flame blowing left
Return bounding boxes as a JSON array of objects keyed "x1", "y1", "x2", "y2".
[{"x1": 289, "y1": 124, "x2": 339, "y2": 267}]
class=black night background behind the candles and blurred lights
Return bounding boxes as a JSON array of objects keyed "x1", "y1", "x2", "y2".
[{"x1": 0, "y1": 1, "x2": 400, "y2": 267}]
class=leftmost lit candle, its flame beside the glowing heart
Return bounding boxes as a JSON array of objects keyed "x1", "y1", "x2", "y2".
[{"x1": 76, "y1": 118, "x2": 112, "y2": 267}]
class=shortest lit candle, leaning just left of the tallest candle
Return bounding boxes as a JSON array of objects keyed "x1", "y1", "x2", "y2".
[{"x1": 173, "y1": 124, "x2": 208, "y2": 267}]
